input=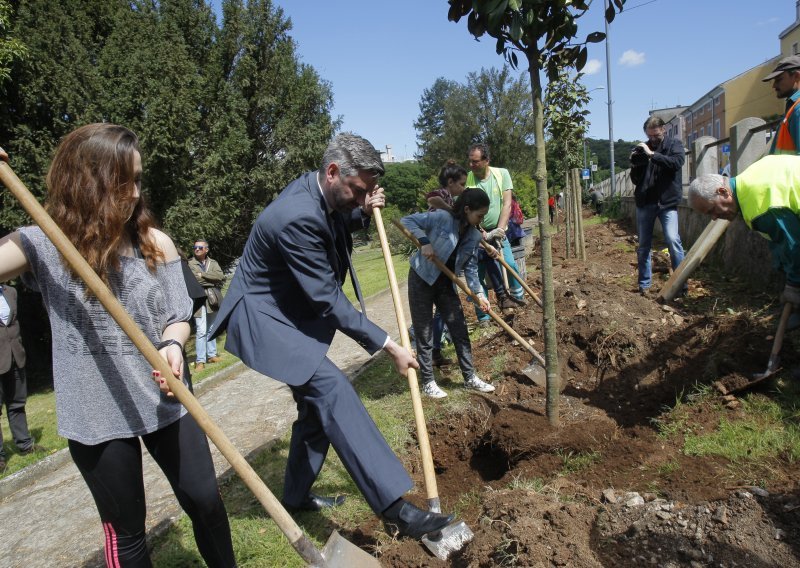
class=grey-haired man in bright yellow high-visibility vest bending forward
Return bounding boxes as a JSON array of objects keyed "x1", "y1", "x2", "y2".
[{"x1": 688, "y1": 155, "x2": 800, "y2": 306}]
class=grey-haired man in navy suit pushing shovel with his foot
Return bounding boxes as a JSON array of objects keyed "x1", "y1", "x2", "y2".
[{"x1": 212, "y1": 134, "x2": 452, "y2": 538}]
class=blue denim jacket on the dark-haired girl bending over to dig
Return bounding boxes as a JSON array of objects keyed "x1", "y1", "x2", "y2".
[{"x1": 400, "y1": 209, "x2": 483, "y2": 295}]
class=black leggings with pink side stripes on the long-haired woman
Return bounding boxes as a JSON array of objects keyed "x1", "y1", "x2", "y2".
[{"x1": 69, "y1": 414, "x2": 236, "y2": 568}]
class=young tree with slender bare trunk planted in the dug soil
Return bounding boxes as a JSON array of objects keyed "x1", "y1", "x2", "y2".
[{"x1": 448, "y1": 0, "x2": 625, "y2": 426}]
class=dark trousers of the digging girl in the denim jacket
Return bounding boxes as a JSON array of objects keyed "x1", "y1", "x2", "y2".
[{"x1": 408, "y1": 268, "x2": 475, "y2": 385}]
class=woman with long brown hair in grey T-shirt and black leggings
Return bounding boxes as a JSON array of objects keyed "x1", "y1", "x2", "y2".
[{"x1": 0, "y1": 124, "x2": 236, "y2": 567}]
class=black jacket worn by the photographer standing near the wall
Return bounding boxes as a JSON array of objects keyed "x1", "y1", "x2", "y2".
[{"x1": 631, "y1": 138, "x2": 686, "y2": 209}]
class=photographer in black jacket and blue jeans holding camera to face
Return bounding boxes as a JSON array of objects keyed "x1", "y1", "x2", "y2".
[{"x1": 631, "y1": 116, "x2": 686, "y2": 295}]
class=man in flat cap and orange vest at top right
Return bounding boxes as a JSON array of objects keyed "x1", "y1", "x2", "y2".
[{"x1": 762, "y1": 55, "x2": 800, "y2": 155}]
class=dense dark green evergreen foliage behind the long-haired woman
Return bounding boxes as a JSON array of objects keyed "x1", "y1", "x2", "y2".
[{"x1": 0, "y1": 0, "x2": 339, "y2": 262}]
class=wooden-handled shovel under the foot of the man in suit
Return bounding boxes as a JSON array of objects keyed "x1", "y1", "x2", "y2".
[{"x1": 372, "y1": 209, "x2": 475, "y2": 560}]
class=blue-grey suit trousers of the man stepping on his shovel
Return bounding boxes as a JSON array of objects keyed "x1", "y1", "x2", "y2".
[{"x1": 283, "y1": 357, "x2": 412, "y2": 515}]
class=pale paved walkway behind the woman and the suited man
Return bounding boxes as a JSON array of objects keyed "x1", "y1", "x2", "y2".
[{"x1": 0, "y1": 285, "x2": 410, "y2": 568}]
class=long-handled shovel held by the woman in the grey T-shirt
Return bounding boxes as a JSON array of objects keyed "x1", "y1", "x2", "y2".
[{"x1": 0, "y1": 160, "x2": 380, "y2": 568}]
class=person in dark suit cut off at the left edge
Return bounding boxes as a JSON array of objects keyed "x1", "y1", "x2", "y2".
[{"x1": 0, "y1": 285, "x2": 36, "y2": 471}]
